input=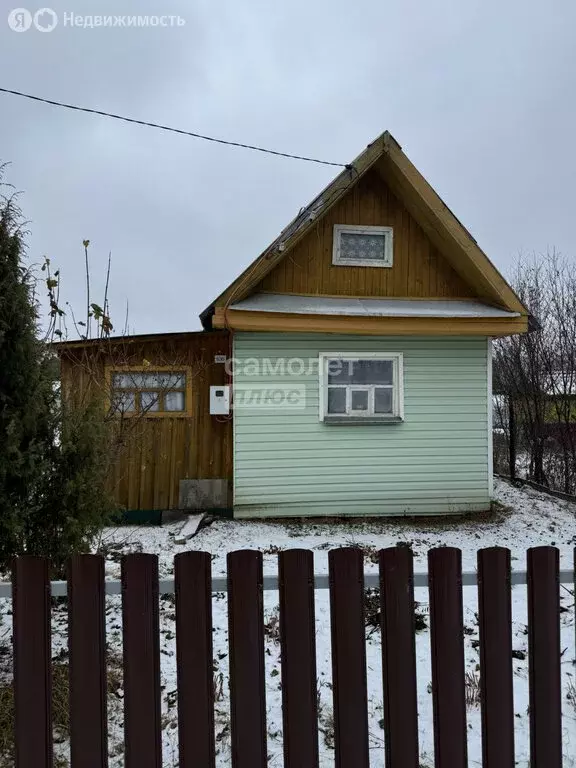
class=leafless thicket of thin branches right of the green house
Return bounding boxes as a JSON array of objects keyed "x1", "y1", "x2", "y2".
[{"x1": 494, "y1": 252, "x2": 576, "y2": 492}]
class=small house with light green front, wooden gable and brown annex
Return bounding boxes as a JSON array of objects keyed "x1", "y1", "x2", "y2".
[{"x1": 56, "y1": 132, "x2": 529, "y2": 517}]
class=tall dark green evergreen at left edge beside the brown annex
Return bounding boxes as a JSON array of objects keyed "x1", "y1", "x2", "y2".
[{"x1": 0, "y1": 167, "x2": 113, "y2": 570}]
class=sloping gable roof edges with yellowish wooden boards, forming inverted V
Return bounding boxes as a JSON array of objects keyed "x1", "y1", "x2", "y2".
[{"x1": 200, "y1": 131, "x2": 528, "y2": 327}]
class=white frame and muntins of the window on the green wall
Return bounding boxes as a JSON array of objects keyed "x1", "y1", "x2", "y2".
[{"x1": 318, "y1": 352, "x2": 404, "y2": 424}]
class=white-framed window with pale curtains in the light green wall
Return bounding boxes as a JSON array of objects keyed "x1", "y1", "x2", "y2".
[{"x1": 319, "y1": 352, "x2": 404, "y2": 424}]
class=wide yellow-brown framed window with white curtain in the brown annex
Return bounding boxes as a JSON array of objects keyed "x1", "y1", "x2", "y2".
[{"x1": 109, "y1": 367, "x2": 189, "y2": 416}]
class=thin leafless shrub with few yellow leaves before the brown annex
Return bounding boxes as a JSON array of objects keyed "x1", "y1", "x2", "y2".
[{"x1": 42, "y1": 240, "x2": 207, "y2": 488}]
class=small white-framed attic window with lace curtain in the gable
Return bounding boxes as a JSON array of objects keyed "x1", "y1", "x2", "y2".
[{"x1": 332, "y1": 224, "x2": 393, "y2": 267}]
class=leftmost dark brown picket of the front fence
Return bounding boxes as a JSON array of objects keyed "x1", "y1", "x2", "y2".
[{"x1": 12, "y1": 555, "x2": 53, "y2": 768}]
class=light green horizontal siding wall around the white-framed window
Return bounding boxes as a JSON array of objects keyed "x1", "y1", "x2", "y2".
[{"x1": 234, "y1": 333, "x2": 491, "y2": 517}]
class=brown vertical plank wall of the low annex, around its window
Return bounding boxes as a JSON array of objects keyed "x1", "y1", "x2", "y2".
[{"x1": 60, "y1": 332, "x2": 232, "y2": 510}]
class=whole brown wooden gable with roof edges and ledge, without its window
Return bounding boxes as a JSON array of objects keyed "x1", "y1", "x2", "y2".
[{"x1": 205, "y1": 132, "x2": 528, "y2": 336}]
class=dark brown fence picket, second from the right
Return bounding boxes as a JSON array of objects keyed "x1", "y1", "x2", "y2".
[{"x1": 478, "y1": 547, "x2": 514, "y2": 768}]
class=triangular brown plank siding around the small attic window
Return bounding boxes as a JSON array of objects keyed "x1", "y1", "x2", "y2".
[{"x1": 256, "y1": 170, "x2": 476, "y2": 298}]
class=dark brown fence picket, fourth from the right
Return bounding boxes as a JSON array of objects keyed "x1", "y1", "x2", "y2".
[{"x1": 379, "y1": 547, "x2": 420, "y2": 768}]
